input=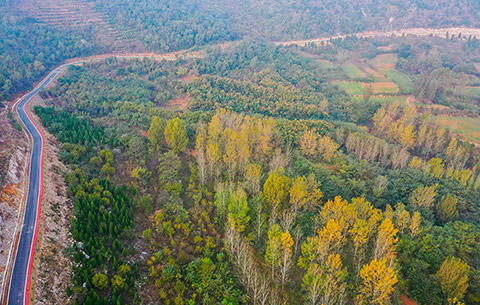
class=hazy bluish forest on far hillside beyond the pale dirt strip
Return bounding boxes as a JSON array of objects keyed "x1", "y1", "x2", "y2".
[{"x1": 95, "y1": 0, "x2": 480, "y2": 51}]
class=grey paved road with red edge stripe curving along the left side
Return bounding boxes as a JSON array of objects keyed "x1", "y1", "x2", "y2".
[{"x1": 8, "y1": 66, "x2": 66, "y2": 304}]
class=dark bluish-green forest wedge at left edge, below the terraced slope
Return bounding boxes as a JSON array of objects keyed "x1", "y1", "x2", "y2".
[{"x1": 0, "y1": 7, "x2": 101, "y2": 102}]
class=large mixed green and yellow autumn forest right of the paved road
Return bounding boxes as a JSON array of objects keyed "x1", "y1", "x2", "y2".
[{"x1": 31, "y1": 35, "x2": 480, "y2": 304}]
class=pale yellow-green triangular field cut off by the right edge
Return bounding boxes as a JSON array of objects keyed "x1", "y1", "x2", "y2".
[{"x1": 434, "y1": 116, "x2": 480, "y2": 144}]
